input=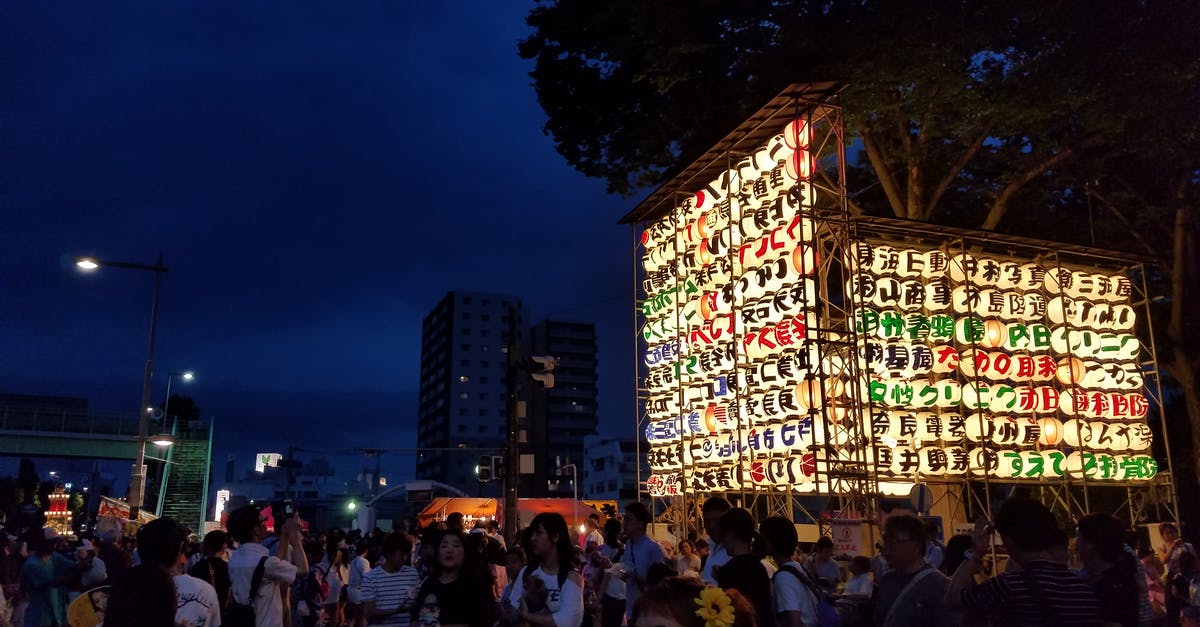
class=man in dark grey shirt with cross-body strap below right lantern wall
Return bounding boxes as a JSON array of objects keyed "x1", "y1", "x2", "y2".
[{"x1": 872, "y1": 514, "x2": 956, "y2": 627}]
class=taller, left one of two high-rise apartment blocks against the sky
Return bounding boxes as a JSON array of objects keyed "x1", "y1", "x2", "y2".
[{"x1": 416, "y1": 292, "x2": 524, "y2": 496}]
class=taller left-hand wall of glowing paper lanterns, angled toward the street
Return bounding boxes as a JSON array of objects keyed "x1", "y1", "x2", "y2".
[{"x1": 641, "y1": 120, "x2": 827, "y2": 496}]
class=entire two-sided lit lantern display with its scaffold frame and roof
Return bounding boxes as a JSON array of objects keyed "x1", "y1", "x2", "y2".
[{"x1": 623, "y1": 83, "x2": 1177, "y2": 535}]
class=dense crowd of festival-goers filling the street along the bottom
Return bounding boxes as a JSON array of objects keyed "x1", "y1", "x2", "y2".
[{"x1": 0, "y1": 497, "x2": 1200, "y2": 627}]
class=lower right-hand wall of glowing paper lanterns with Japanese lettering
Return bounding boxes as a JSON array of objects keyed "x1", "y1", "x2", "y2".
[{"x1": 845, "y1": 243, "x2": 1158, "y2": 482}]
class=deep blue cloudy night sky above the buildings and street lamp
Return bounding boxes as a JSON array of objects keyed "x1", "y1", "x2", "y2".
[{"x1": 0, "y1": 1, "x2": 635, "y2": 478}]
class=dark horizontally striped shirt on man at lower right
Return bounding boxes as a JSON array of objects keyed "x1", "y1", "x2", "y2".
[{"x1": 962, "y1": 561, "x2": 1100, "y2": 627}]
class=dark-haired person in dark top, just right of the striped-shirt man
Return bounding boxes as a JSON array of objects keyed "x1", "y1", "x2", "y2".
[{"x1": 1075, "y1": 514, "x2": 1139, "y2": 627}]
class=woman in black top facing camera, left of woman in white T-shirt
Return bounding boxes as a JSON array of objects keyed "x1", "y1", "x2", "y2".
[{"x1": 412, "y1": 529, "x2": 496, "y2": 627}]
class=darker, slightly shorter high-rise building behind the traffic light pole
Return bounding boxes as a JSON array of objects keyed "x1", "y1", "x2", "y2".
[{"x1": 522, "y1": 320, "x2": 598, "y2": 497}]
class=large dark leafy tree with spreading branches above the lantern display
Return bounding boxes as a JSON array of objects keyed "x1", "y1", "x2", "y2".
[{"x1": 518, "y1": 0, "x2": 1200, "y2": 511}]
